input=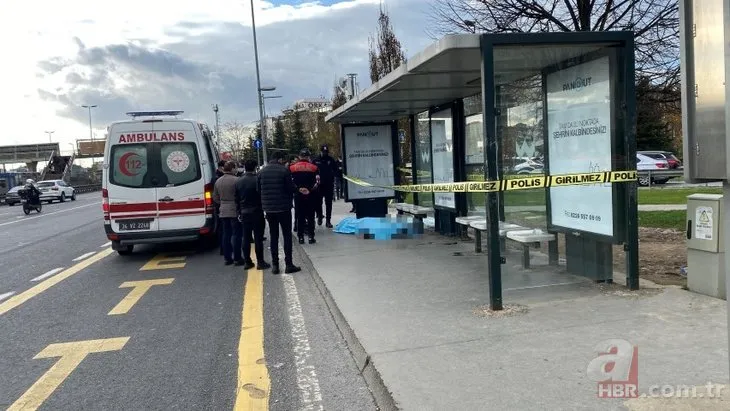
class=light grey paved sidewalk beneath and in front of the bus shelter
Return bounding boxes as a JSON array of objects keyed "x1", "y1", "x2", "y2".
[{"x1": 296, "y1": 201, "x2": 730, "y2": 411}]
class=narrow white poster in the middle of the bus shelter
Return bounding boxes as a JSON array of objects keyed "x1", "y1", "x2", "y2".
[{"x1": 431, "y1": 109, "x2": 456, "y2": 209}]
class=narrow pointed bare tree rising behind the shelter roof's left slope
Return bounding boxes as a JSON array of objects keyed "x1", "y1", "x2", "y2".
[{"x1": 368, "y1": 4, "x2": 406, "y2": 83}]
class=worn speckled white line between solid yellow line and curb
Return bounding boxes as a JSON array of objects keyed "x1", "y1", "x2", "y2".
[{"x1": 281, "y1": 267, "x2": 324, "y2": 410}]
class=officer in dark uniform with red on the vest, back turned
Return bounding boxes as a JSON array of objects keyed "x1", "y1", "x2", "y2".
[{"x1": 289, "y1": 148, "x2": 320, "y2": 244}]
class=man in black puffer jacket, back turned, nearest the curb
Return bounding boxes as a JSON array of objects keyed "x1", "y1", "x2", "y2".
[{"x1": 258, "y1": 151, "x2": 301, "y2": 274}]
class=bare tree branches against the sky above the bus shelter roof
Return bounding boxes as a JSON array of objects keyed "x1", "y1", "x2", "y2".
[{"x1": 431, "y1": 0, "x2": 679, "y2": 89}]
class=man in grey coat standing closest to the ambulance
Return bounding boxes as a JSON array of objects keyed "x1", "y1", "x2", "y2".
[{"x1": 213, "y1": 161, "x2": 244, "y2": 265}]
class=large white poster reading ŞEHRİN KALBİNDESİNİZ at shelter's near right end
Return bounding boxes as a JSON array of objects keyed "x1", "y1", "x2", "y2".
[{"x1": 546, "y1": 57, "x2": 614, "y2": 236}]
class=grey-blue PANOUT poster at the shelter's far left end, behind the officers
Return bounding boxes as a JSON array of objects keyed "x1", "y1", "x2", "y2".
[{"x1": 343, "y1": 124, "x2": 395, "y2": 200}]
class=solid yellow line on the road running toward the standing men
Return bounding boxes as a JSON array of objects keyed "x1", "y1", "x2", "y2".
[{"x1": 234, "y1": 262, "x2": 271, "y2": 411}]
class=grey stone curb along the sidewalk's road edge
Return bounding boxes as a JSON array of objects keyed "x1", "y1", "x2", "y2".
[{"x1": 294, "y1": 244, "x2": 400, "y2": 411}]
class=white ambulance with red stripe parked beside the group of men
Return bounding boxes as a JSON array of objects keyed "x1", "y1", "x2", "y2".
[{"x1": 102, "y1": 110, "x2": 218, "y2": 255}]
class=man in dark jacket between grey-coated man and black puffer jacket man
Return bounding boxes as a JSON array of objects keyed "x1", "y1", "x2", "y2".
[{"x1": 236, "y1": 160, "x2": 271, "y2": 270}]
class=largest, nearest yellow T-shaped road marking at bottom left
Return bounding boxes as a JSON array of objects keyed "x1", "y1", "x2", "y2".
[{"x1": 8, "y1": 337, "x2": 129, "y2": 411}]
